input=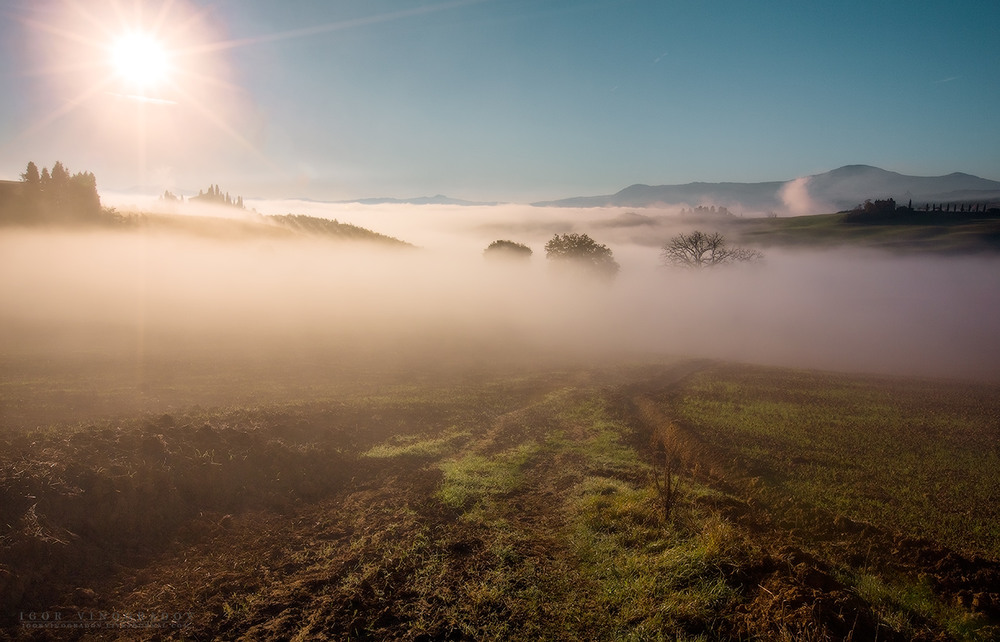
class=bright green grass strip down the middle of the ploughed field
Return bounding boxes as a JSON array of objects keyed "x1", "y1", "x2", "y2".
[{"x1": 426, "y1": 376, "x2": 742, "y2": 640}]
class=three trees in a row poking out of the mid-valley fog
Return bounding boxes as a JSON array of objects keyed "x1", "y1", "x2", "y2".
[{"x1": 483, "y1": 230, "x2": 764, "y2": 279}]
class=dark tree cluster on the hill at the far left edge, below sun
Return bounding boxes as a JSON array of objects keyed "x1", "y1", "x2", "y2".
[{"x1": 0, "y1": 161, "x2": 103, "y2": 224}]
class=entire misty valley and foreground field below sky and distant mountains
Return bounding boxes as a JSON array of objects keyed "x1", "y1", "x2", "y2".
[{"x1": 0, "y1": 171, "x2": 1000, "y2": 640}]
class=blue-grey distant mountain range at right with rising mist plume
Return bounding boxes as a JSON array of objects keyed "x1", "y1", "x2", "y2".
[{"x1": 532, "y1": 165, "x2": 1000, "y2": 214}]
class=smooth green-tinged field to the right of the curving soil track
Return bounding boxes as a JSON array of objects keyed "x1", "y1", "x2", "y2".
[{"x1": 676, "y1": 367, "x2": 1000, "y2": 558}]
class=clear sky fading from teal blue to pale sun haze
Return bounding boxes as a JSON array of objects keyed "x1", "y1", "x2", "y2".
[{"x1": 0, "y1": 0, "x2": 1000, "y2": 202}]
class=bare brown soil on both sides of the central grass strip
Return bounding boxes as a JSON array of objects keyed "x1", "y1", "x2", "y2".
[{"x1": 0, "y1": 363, "x2": 1000, "y2": 640}]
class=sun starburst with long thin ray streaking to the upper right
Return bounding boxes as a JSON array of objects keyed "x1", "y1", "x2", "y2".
[{"x1": 3, "y1": 0, "x2": 486, "y2": 188}]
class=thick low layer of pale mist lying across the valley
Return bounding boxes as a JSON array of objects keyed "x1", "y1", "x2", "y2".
[{"x1": 0, "y1": 204, "x2": 1000, "y2": 424}]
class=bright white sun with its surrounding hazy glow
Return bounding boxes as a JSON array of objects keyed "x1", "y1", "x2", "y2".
[{"x1": 18, "y1": 0, "x2": 274, "y2": 175}]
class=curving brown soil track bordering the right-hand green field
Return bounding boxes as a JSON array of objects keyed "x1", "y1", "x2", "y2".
[{"x1": 628, "y1": 360, "x2": 1000, "y2": 640}]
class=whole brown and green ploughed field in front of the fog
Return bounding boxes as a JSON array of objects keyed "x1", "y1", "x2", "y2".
[{"x1": 0, "y1": 361, "x2": 1000, "y2": 640}]
